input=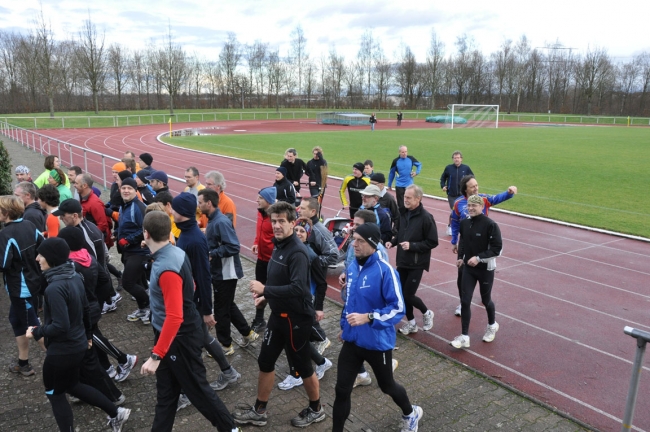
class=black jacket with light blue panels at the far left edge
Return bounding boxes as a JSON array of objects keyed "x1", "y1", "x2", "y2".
[{"x1": 0, "y1": 219, "x2": 43, "y2": 298}]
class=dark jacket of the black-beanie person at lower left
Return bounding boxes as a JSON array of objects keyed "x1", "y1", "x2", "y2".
[{"x1": 33, "y1": 261, "x2": 92, "y2": 355}]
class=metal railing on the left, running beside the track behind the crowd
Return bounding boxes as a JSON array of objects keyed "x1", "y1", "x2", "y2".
[{"x1": 0, "y1": 121, "x2": 185, "y2": 190}]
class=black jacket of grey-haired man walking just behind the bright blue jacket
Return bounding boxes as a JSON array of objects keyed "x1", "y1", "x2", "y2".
[{"x1": 391, "y1": 203, "x2": 438, "y2": 271}]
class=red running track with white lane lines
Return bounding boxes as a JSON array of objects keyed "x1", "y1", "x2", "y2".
[{"x1": 35, "y1": 121, "x2": 650, "y2": 431}]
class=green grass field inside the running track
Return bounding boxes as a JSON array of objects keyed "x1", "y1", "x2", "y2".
[{"x1": 165, "y1": 127, "x2": 650, "y2": 237}]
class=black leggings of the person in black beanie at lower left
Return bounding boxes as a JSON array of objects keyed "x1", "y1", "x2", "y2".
[{"x1": 43, "y1": 350, "x2": 117, "y2": 432}]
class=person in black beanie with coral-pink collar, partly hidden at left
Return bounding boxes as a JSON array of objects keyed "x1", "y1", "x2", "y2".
[{"x1": 58, "y1": 227, "x2": 137, "y2": 405}]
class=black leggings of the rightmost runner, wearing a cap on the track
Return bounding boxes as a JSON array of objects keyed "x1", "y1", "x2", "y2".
[{"x1": 460, "y1": 264, "x2": 495, "y2": 336}]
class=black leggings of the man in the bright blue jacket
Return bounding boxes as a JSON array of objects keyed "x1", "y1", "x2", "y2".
[{"x1": 332, "y1": 342, "x2": 413, "y2": 432}]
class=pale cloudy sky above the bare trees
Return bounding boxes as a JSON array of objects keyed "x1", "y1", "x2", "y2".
[{"x1": 0, "y1": 0, "x2": 650, "y2": 61}]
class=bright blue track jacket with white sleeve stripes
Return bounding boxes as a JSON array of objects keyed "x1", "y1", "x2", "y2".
[{"x1": 341, "y1": 252, "x2": 404, "y2": 351}]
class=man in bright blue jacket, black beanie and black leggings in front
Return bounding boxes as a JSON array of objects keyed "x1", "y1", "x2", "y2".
[{"x1": 332, "y1": 223, "x2": 423, "y2": 432}]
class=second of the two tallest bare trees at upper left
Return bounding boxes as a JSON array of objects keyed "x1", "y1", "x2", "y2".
[{"x1": 77, "y1": 17, "x2": 106, "y2": 114}]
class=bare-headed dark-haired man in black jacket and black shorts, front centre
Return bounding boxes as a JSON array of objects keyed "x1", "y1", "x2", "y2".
[{"x1": 233, "y1": 202, "x2": 325, "y2": 427}]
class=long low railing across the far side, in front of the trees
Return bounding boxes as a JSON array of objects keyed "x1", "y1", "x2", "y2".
[{"x1": 0, "y1": 110, "x2": 650, "y2": 129}]
